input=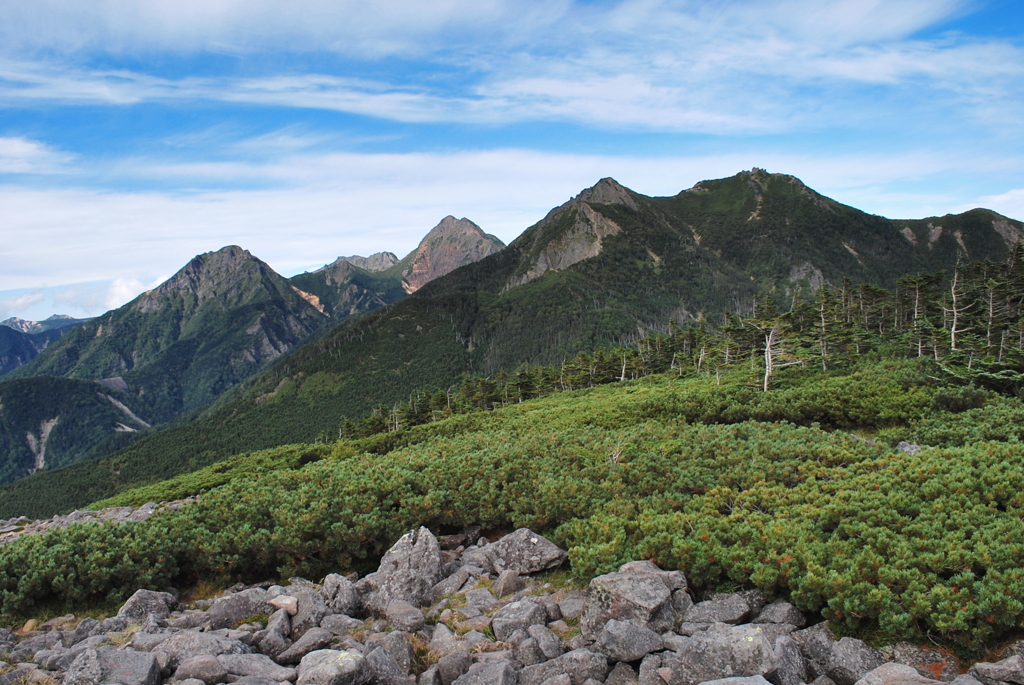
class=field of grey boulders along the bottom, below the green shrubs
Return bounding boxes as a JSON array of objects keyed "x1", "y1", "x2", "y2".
[{"x1": 0, "y1": 528, "x2": 1024, "y2": 685}]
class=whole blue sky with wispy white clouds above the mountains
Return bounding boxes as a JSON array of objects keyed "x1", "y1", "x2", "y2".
[{"x1": 0, "y1": 0, "x2": 1024, "y2": 318}]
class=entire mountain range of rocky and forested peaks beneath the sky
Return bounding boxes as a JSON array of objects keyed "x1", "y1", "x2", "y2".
[{"x1": 0, "y1": 169, "x2": 1024, "y2": 515}]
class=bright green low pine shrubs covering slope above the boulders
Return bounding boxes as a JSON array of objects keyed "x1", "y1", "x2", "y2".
[{"x1": 0, "y1": 354, "x2": 1024, "y2": 648}]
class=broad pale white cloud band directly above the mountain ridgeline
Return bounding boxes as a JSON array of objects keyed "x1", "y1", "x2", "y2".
[{"x1": 0, "y1": 148, "x2": 1024, "y2": 314}]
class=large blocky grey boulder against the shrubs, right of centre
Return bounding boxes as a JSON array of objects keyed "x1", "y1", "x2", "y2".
[{"x1": 580, "y1": 572, "x2": 675, "y2": 640}]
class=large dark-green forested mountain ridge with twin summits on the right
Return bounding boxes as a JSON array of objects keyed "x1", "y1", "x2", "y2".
[{"x1": 4, "y1": 170, "x2": 1024, "y2": 506}]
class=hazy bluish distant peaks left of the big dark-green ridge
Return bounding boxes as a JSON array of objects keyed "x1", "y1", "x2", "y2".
[{"x1": 0, "y1": 219, "x2": 500, "y2": 483}]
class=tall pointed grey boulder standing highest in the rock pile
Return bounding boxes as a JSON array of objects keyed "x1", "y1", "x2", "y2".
[{"x1": 355, "y1": 527, "x2": 444, "y2": 615}]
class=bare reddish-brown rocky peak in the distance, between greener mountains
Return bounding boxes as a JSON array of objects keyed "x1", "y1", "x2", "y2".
[{"x1": 400, "y1": 216, "x2": 505, "y2": 293}]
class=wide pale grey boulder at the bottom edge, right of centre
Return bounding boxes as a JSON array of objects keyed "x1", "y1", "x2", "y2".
[{"x1": 662, "y1": 624, "x2": 778, "y2": 685}]
